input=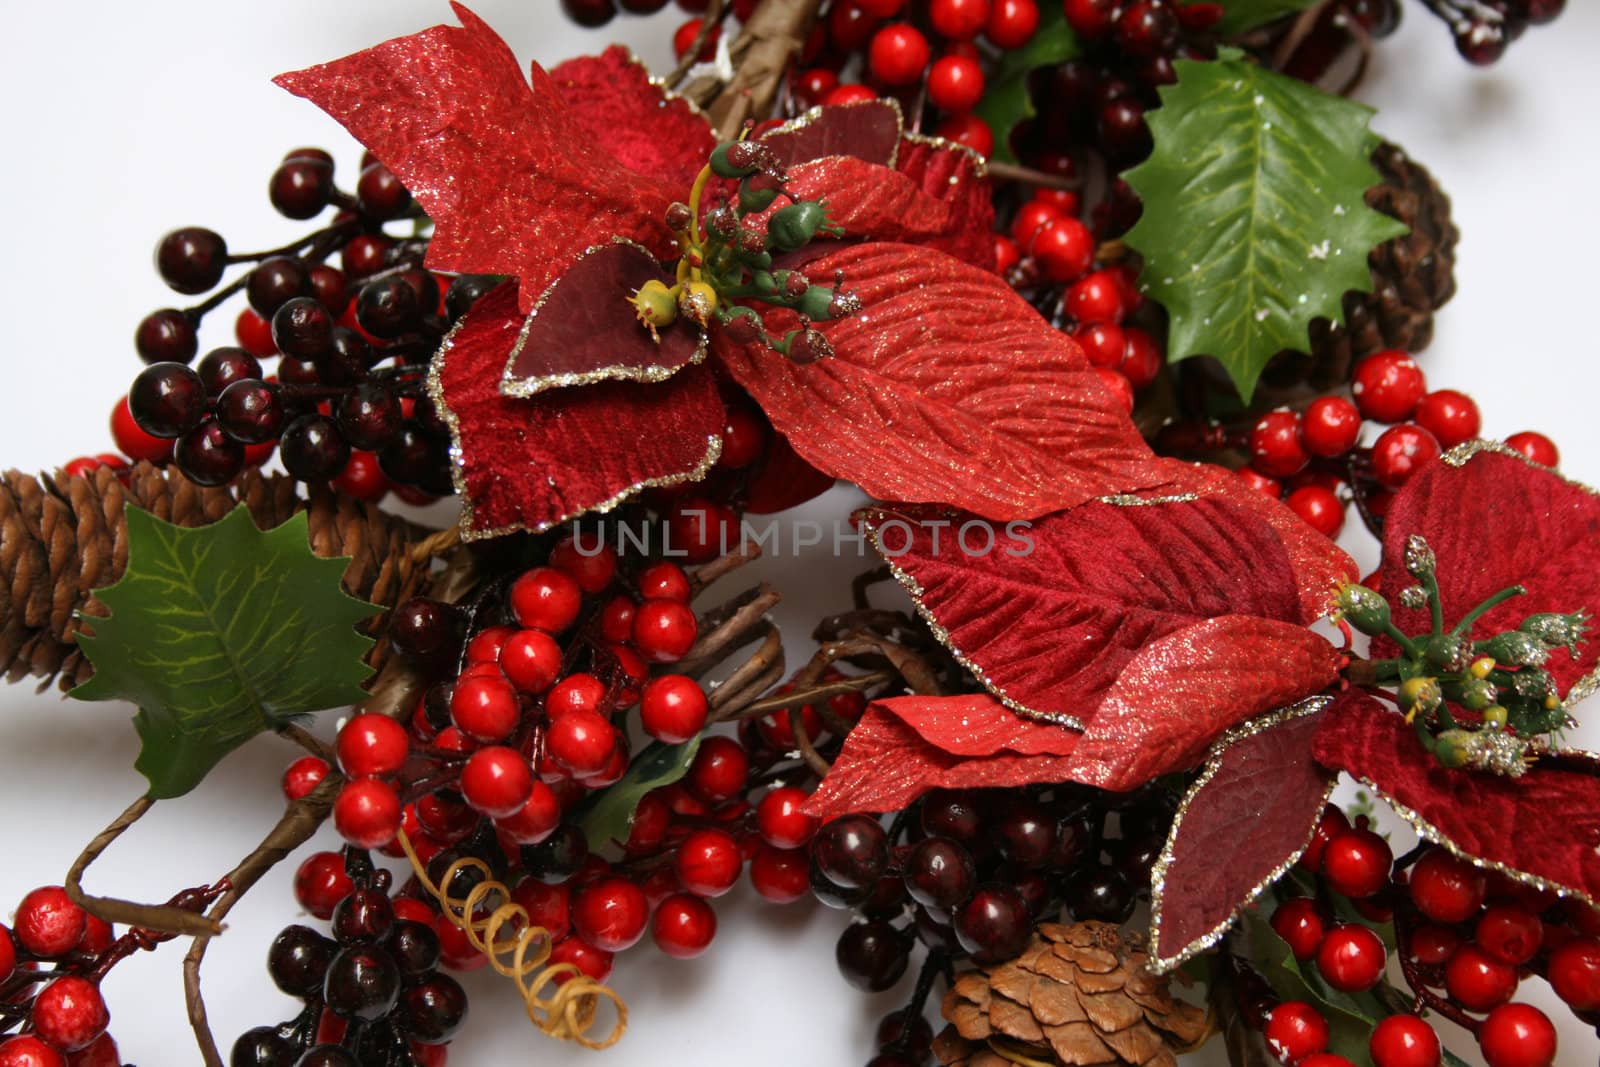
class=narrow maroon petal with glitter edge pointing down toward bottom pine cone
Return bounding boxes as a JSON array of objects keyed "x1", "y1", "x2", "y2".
[{"x1": 1150, "y1": 697, "x2": 1334, "y2": 971}]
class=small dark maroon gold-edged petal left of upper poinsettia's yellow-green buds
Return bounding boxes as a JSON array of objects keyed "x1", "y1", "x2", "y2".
[{"x1": 501, "y1": 242, "x2": 704, "y2": 397}]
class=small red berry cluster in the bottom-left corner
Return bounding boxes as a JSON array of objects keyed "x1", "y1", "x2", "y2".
[{"x1": 0, "y1": 886, "x2": 122, "y2": 1067}]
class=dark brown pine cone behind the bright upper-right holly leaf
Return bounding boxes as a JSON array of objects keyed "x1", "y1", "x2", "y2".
[{"x1": 1262, "y1": 142, "x2": 1461, "y2": 392}]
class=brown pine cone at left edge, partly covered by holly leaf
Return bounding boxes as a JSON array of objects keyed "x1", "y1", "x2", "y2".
[{"x1": 0, "y1": 462, "x2": 424, "y2": 689}]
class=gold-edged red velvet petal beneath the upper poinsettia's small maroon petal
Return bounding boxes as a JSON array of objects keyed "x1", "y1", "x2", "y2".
[{"x1": 429, "y1": 283, "x2": 723, "y2": 537}]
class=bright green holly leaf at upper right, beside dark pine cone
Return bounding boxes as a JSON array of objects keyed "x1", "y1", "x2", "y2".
[{"x1": 1125, "y1": 48, "x2": 1406, "y2": 402}]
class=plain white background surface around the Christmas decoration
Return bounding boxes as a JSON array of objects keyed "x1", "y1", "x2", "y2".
[{"x1": 0, "y1": 0, "x2": 1600, "y2": 1067}]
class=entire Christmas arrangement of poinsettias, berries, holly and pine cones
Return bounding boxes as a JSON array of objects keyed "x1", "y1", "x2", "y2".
[{"x1": 0, "y1": 0, "x2": 1600, "y2": 1067}]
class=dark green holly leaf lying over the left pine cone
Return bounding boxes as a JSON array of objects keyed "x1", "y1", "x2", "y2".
[{"x1": 72, "y1": 506, "x2": 379, "y2": 798}]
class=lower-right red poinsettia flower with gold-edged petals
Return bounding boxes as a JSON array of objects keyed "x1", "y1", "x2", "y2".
[{"x1": 810, "y1": 442, "x2": 1600, "y2": 968}]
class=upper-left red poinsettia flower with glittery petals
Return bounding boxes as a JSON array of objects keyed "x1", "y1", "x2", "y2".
[{"x1": 278, "y1": 5, "x2": 1168, "y2": 536}]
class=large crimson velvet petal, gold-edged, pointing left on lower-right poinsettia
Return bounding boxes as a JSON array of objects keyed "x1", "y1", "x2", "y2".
[{"x1": 861, "y1": 499, "x2": 1310, "y2": 721}]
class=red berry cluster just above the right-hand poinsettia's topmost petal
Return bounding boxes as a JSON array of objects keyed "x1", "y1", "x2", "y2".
[{"x1": 1240, "y1": 349, "x2": 1560, "y2": 537}]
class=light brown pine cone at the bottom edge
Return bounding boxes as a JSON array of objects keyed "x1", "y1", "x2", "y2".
[{"x1": 933, "y1": 921, "x2": 1206, "y2": 1067}]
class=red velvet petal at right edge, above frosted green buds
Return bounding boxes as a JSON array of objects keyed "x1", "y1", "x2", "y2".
[{"x1": 1374, "y1": 443, "x2": 1600, "y2": 699}]
